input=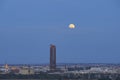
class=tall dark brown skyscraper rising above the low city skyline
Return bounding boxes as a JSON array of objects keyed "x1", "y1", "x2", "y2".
[{"x1": 50, "y1": 44, "x2": 56, "y2": 70}]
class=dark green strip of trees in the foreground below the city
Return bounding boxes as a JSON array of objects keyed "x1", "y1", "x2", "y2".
[{"x1": 0, "y1": 73, "x2": 120, "y2": 80}]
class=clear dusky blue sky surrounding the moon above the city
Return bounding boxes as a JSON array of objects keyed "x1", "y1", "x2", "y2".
[{"x1": 0, "y1": 0, "x2": 120, "y2": 64}]
